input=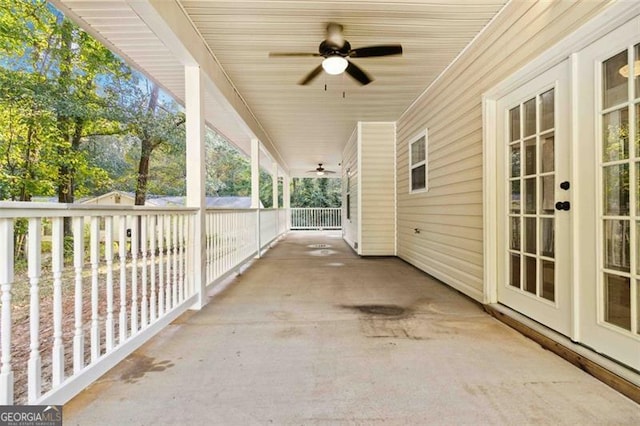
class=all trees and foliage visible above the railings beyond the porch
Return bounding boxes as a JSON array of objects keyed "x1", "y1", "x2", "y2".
[{"x1": 0, "y1": 0, "x2": 340, "y2": 211}]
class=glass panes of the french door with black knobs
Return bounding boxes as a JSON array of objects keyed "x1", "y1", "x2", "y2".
[{"x1": 506, "y1": 88, "x2": 556, "y2": 302}]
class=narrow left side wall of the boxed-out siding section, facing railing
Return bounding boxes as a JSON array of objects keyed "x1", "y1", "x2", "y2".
[{"x1": 342, "y1": 129, "x2": 359, "y2": 251}]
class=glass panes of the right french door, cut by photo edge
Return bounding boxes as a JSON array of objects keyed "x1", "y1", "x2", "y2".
[{"x1": 599, "y1": 44, "x2": 640, "y2": 335}]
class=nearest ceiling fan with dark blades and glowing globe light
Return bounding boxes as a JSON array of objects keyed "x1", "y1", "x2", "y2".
[{"x1": 269, "y1": 22, "x2": 402, "y2": 85}]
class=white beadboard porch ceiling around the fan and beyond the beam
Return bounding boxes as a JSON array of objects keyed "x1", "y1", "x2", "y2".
[{"x1": 53, "y1": 0, "x2": 507, "y2": 176}]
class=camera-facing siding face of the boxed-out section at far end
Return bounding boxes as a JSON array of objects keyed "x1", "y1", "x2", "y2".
[{"x1": 358, "y1": 122, "x2": 396, "y2": 256}]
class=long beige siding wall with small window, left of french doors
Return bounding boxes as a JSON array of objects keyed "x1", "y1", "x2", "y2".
[{"x1": 396, "y1": 1, "x2": 608, "y2": 301}]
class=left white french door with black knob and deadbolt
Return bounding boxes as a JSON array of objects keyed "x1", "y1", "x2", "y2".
[{"x1": 497, "y1": 61, "x2": 572, "y2": 335}]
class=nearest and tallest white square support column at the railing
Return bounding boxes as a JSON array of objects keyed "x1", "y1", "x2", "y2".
[{"x1": 185, "y1": 65, "x2": 207, "y2": 309}]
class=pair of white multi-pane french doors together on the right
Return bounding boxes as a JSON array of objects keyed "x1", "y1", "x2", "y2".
[{"x1": 495, "y1": 17, "x2": 640, "y2": 370}]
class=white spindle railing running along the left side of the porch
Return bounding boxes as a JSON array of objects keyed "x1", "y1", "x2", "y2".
[{"x1": 0, "y1": 202, "x2": 286, "y2": 405}]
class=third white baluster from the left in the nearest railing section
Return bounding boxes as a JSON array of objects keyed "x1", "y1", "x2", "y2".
[{"x1": 51, "y1": 217, "x2": 64, "y2": 388}]
